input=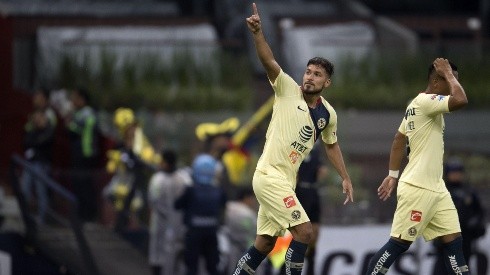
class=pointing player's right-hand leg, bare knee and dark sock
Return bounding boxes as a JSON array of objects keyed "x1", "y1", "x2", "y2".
[{"x1": 285, "y1": 222, "x2": 313, "y2": 275}]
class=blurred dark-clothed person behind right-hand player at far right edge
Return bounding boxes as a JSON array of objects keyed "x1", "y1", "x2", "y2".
[{"x1": 433, "y1": 159, "x2": 487, "y2": 275}]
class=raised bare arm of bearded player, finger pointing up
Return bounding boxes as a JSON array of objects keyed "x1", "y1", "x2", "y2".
[{"x1": 247, "y1": 3, "x2": 281, "y2": 82}]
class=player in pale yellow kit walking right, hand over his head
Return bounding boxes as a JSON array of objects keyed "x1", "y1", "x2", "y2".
[{"x1": 366, "y1": 58, "x2": 470, "y2": 275}]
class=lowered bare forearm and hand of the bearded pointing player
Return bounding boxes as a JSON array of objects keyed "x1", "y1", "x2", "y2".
[{"x1": 324, "y1": 142, "x2": 354, "y2": 204}]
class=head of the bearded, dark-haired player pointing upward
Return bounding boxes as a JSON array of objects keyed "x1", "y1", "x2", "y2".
[{"x1": 302, "y1": 57, "x2": 334, "y2": 94}]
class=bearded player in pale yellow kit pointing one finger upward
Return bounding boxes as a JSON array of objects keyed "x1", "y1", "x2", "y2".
[{"x1": 233, "y1": 3, "x2": 353, "y2": 275}]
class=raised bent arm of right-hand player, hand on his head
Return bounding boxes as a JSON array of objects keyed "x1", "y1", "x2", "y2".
[{"x1": 433, "y1": 58, "x2": 468, "y2": 111}]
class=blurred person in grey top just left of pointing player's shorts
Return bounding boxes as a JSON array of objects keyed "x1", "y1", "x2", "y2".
[{"x1": 225, "y1": 187, "x2": 258, "y2": 274}]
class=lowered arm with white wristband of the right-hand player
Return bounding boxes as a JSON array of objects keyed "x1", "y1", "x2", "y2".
[{"x1": 378, "y1": 132, "x2": 407, "y2": 201}]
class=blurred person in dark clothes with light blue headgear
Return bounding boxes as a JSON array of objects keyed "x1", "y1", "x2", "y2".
[{"x1": 175, "y1": 154, "x2": 226, "y2": 275}]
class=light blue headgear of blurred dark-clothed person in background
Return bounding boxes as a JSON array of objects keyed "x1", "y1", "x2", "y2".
[{"x1": 192, "y1": 154, "x2": 219, "y2": 185}]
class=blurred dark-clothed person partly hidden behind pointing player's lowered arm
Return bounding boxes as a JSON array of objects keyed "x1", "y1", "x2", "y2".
[{"x1": 296, "y1": 143, "x2": 327, "y2": 275}]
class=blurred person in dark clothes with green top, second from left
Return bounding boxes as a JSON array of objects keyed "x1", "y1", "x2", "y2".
[{"x1": 65, "y1": 88, "x2": 99, "y2": 224}]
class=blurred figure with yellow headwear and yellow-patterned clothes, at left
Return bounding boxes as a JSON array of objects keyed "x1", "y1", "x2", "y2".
[{"x1": 103, "y1": 108, "x2": 161, "y2": 232}]
